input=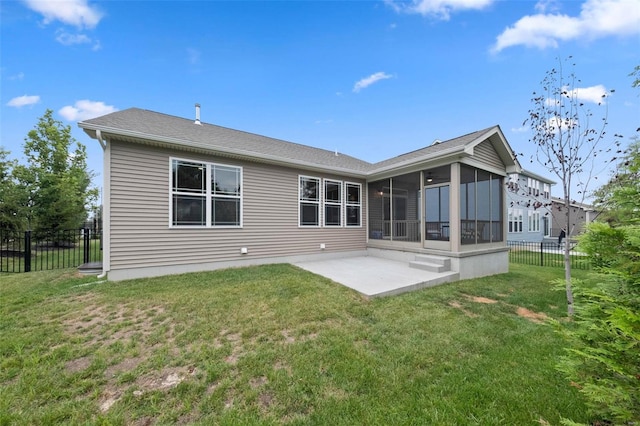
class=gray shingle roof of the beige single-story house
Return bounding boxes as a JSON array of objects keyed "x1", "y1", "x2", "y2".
[{"x1": 78, "y1": 108, "x2": 508, "y2": 175}]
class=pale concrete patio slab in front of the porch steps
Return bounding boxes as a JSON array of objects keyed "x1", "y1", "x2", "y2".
[{"x1": 295, "y1": 251, "x2": 459, "y2": 297}]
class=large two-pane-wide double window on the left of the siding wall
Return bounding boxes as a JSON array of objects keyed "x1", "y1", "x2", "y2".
[{"x1": 170, "y1": 159, "x2": 242, "y2": 227}]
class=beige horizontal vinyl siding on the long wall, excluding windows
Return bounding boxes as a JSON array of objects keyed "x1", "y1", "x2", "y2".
[{"x1": 110, "y1": 141, "x2": 367, "y2": 270}]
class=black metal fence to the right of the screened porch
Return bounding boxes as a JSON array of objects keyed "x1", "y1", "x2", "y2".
[{"x1": 507, "y1": 240, "x2": 591, "y2": 270}]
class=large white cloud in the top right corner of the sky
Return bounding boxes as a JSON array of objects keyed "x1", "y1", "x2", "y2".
[{"x1": 491, "y1": 0, "x2": 640, "y2": 53}]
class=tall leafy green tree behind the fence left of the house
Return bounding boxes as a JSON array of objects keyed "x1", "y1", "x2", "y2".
[{"x1": 15, "y1": 110, "x2": 97, "y2": 233}]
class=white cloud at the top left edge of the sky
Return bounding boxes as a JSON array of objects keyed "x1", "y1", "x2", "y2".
[{"x1": 24, "y1": 0, "x2": 103, "y2": 28}]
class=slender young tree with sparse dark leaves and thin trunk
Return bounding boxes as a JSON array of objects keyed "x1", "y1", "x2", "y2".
[{"x1": 524, "y1": 57, "x2": 621, "y2": 315}]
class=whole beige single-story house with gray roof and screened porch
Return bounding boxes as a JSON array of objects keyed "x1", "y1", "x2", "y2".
[{"x1": 79, "y1": 107, "x2": 520, "y2": 280}]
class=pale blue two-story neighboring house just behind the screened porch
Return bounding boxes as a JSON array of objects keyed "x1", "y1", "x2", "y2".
[{"x1": 507, "y1": 170, "x2": 555, "y2": 243}]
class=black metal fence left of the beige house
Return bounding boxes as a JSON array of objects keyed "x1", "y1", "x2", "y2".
[{"x1": 0, "y1": 228, "x2": 102, "y2": 272}]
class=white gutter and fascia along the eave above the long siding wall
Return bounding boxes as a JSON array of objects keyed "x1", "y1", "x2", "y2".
[{"x1": 78, "y1": 122, "x2": 368, "y2": 179}]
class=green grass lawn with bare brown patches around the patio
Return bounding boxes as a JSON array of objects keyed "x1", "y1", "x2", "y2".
[{"x1": 0, "y1": 265, "x2": 590, "y2": 425}]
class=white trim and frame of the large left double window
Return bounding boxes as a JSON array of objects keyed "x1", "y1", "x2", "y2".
[{"x1": 169, "y1": 157, "x2": 244, "y2": 229}]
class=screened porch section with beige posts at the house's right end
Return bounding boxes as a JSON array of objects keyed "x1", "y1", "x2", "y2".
[{"x1": 368, "y1": 163, "x2": 505, "y2": 252}]
